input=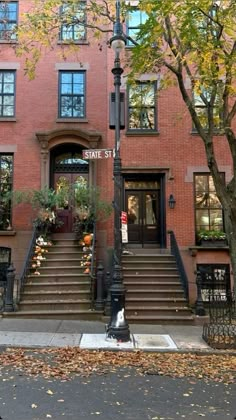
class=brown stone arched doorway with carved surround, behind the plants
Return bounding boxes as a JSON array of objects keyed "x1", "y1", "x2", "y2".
[{"x1": 36, "y1": 128, "x2": 102, "y2": 232}]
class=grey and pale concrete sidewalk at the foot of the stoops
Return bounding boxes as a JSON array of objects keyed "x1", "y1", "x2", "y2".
[{"x1": 0, "y1": 318, "x2": 218, "y2": 352}]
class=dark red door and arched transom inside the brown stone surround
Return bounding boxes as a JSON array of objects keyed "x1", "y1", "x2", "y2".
[{"x1": 50, "y1": 143, "x2": 89, "y2": 233}]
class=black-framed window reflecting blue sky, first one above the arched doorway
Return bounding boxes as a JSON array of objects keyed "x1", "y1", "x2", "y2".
[{"x1": 59, "y1": 71, "x2": 85, "y2": 118}]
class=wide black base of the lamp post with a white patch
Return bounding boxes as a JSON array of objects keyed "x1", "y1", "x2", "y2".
[{"x1": 107, "y1": 265, "x2": 130, "y2": 342}]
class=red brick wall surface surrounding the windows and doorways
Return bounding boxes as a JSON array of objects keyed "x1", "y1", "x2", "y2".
[{"x1": 0, "y1": 0, "x2": 231, "y2": 301}]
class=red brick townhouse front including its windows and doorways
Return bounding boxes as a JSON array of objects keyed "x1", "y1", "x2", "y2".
[{"x1": 0, "y1": 0, "x2": 232, "y2": 318}]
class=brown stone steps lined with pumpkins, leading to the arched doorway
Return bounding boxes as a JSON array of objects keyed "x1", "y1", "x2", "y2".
[{"x1": 13, "y1": 234, "x2": 101, "y2": 320}]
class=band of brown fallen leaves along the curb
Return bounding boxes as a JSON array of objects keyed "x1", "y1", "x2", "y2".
[{"x1": 0, "y1": 347, "x2": 236, "y2": 384}]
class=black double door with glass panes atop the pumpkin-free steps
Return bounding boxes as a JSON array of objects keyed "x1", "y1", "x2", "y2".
[{"x1": 126, "y1": 190, "x2": 160, "y2": 245}]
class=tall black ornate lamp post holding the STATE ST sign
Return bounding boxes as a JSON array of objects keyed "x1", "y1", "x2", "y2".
[{"x1": 107, "y1": 0, "x2": 130, "y2": 342}]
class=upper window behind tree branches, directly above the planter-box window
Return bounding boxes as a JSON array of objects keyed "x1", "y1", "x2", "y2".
[{"x1": 193, "y1": 87, "x2": 222, "y2": 131}]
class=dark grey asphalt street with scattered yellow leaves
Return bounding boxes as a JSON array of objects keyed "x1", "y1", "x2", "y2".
[{"x1": 0, "y1": 368, "x2": 236, "y2": 420}]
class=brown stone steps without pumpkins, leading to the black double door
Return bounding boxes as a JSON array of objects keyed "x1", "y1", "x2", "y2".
[{"x1": 122, "y1": 252, "x2": 194, "y2": 324}]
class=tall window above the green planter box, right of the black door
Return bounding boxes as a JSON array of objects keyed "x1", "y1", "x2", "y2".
[{"x1": 195, "y1": 174, "x2": 224, "y2": 232}]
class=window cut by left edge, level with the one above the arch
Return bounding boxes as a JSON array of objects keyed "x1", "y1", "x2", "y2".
[{"x1": 0, "y1": 70, "x2": 15, "y2": 118}]
